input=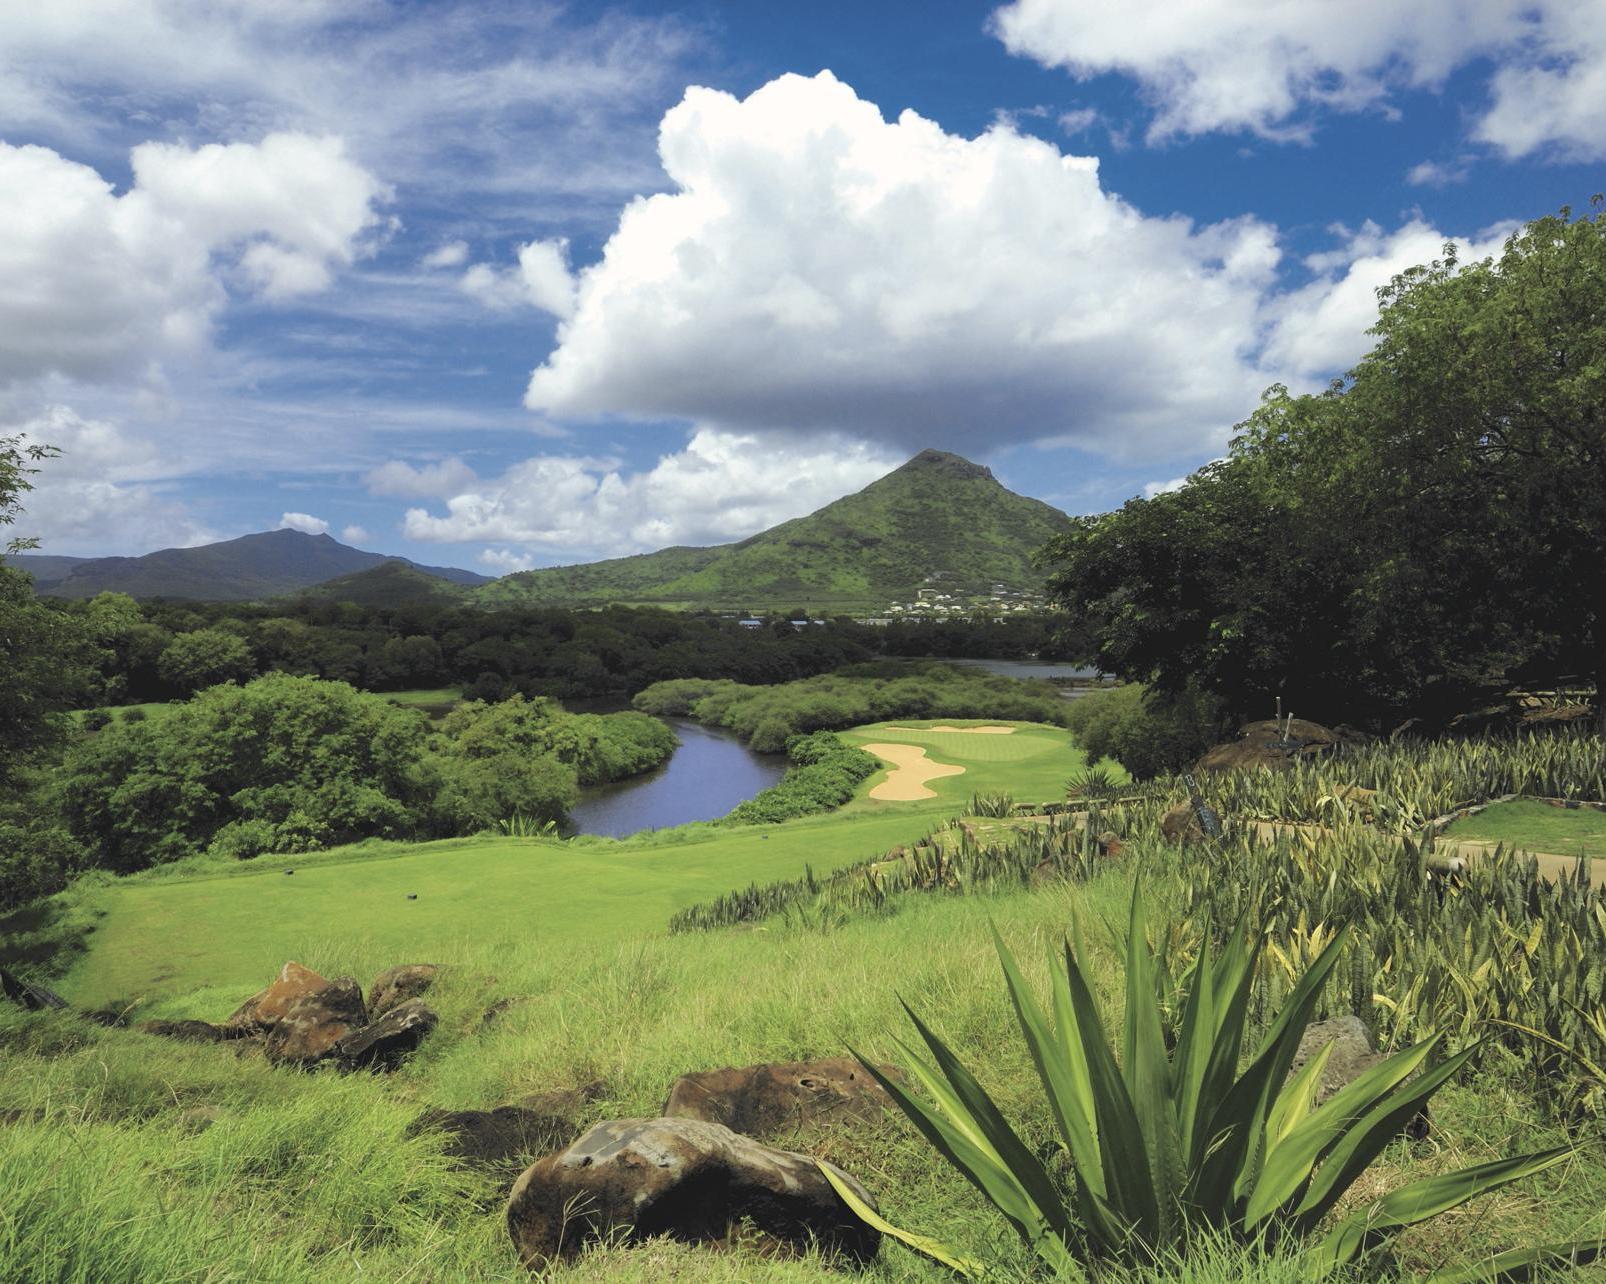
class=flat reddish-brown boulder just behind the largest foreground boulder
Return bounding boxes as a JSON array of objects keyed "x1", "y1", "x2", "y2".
[{"x1": 663, "y1": 1056, "x2": 890, "y2": 1136}]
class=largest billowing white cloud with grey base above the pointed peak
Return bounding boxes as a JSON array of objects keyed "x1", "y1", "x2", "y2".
[{"x1": 525, "y1": 72, "x2": 1278, "y2": 454}]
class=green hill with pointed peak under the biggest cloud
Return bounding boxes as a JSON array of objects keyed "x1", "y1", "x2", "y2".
[{"x1": 474, "y1": 451, "x2": 1068, "y2": 608}]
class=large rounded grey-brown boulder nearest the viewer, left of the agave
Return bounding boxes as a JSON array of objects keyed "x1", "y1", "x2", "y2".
[{"x1": 507, "y1": 1119, "x2": 880, "y2": 1270}]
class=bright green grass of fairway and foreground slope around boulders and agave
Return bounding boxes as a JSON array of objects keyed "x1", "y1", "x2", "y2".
[{"x1": 0, "y1": 727, "x2": 1606, "y2": 1284}]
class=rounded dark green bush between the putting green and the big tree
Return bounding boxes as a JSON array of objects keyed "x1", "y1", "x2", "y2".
[{"x1": 1066, "y1": 682, "x2": 1222, "y2": 778}]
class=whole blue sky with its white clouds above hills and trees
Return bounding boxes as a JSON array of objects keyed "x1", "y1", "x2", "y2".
[{"x1": 0, "y1": 0, "x2": 1606, "y2": 573}]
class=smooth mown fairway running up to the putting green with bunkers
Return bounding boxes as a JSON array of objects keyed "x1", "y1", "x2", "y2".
[{"x1": 61, "y1": 724, "x2": 1081, "y2": 1016}]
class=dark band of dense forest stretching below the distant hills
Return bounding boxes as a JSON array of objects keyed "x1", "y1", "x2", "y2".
[{"x1": 40, "y1": 592, "x2": 1057, "y2": 705}]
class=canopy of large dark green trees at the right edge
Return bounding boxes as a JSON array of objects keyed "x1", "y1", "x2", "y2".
[{"x1": 1044, "y1": 210, "x2": 1606, "y2": 725}]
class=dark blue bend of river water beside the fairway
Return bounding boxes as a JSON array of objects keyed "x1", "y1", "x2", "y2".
[{"x1": 569, "y1": 717, "x2": 787, "y2": 838}]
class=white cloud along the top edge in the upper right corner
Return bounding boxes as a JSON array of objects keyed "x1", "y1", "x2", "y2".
[{"x1": 991, "y1": 0, "x2": 1606, "y2": 157}]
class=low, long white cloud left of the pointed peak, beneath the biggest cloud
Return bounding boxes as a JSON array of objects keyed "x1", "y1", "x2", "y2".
[{"x1": 403, "y1": 429, "x2": 903, "y2": 555}]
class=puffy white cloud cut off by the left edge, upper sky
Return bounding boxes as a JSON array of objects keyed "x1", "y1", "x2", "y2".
[{"x1": 0, "y1": 135, "x2": 384, "y2": 387}]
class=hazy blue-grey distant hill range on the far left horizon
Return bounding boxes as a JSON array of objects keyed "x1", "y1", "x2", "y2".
[{"x1": 6, "y1": 531, "x2": 490, "y2": 602}]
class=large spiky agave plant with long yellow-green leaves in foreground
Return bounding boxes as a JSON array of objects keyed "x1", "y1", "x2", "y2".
[{"x1": 822, "y1": 892, "x2": 1606, "y2": 1284}]
